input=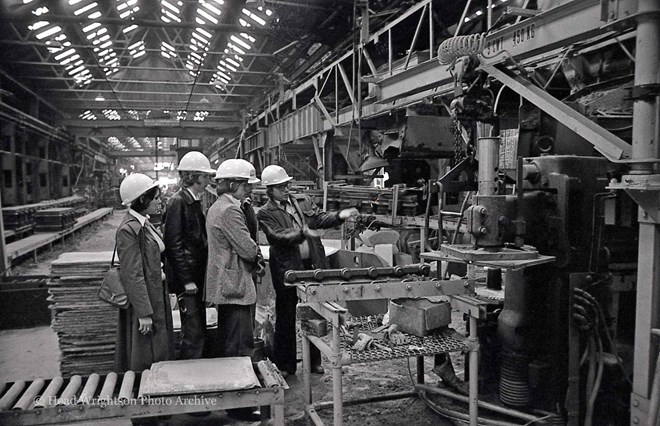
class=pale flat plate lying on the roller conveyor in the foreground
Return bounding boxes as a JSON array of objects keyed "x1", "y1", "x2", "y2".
[{"x1": 142, "y1": 357, "x2": 259, "y2": 396}]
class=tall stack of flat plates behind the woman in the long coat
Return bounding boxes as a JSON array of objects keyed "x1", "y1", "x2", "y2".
[{"x1": 48, "y1": 251, "x2": 118, "y2": 377}]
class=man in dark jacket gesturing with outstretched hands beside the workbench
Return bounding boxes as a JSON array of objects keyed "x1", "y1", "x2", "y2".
[{"x1": 257, "y1": 165, "x2": 358, "y2": 377}]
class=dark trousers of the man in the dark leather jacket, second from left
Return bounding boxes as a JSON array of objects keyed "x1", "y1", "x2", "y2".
[{"x1": 179, "y1": 292, "x2": 206, "y2": 359}]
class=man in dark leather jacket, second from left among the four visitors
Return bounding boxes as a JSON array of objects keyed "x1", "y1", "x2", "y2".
[{"x1": 164, "y1": 151, "x2": 215, "y2": 359}]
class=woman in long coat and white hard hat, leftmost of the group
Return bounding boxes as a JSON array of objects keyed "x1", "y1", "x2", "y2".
[{"x1": 115, "y1": 173, "x2": 174, "y2": 371}]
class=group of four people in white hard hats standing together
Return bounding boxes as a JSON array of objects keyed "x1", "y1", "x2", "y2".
[{"x1": 116, "y1": 151, "x2": 358, "y2": 417}]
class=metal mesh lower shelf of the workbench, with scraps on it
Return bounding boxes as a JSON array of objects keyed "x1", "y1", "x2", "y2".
[{"x1": 341, "y1": 317, "x2": 468, "y2": 363}]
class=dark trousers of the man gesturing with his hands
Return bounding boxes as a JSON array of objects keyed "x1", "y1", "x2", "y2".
[{"x1": 274, "y1": 288, "x2": 321, "y2": 374}]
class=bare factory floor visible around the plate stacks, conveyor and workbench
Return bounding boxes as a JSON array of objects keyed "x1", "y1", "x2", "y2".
[{"x1": 0, "y1": 212, "x2": 454, "y2": 426}]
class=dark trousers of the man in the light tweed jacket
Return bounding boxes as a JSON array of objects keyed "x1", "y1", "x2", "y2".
[{"x1": 216, "y1": 305, "x2": 254, "y2": 357}]
